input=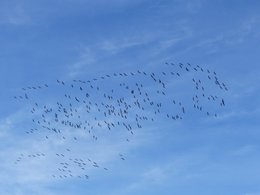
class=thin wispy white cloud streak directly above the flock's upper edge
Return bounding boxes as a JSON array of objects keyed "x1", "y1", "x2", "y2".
[{"x1": 67, "y1": 24, "x2": 192, "y2": 78}]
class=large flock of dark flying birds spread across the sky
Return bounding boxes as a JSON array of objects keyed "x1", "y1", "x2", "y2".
[{"x1": 13, "y1": 62, "x2": 228, "y2": 179}]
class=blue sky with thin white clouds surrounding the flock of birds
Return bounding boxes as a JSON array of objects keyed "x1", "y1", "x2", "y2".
[{"x1": 0, "y1": 0, "x2": 260, "y2": 195}]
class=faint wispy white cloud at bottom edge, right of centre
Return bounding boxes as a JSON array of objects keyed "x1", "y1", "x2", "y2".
[{"x1": 118, "y1": 153, "x2": 205, "y2": 194}]
